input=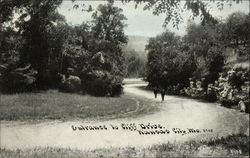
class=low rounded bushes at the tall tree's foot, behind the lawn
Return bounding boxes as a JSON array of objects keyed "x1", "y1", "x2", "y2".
[{"x1": 58, "y1": 52, "x2": 123, "y2": 97}]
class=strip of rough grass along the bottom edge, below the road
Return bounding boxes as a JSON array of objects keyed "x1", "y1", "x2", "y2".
[{"x1": 0, "y1": 135, "x2": 249, "y2": 158}]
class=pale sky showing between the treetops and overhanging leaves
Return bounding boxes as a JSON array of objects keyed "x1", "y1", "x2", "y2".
[{"x1": 58, "y1": 0, "x2": 250, "y2": 37}]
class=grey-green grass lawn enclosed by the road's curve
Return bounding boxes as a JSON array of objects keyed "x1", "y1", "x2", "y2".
[{"x1": 0, "y1": 90, "x2": 155, "y2": 120}]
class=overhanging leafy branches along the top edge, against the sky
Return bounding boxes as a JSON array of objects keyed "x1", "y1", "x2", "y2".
[{"x1": 0, "y1": 0, "x2": 242, "y2": 28}]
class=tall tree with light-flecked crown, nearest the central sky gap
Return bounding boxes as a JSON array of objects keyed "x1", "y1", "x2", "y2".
[{"x1": 92, "y1": 3, "x2": 127, "y2": 76}]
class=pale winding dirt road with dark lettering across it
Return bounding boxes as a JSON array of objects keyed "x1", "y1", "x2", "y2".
[{"x1": 1, "y1": 81, "x2": 249, "y2": 150}]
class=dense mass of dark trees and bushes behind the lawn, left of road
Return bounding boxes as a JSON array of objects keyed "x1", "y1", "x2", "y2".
[{"x1": 0, "y1": 0, "x2": 127, "y2": 96}]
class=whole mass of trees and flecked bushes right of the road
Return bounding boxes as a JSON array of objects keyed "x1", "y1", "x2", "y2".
[{"x1": 146, "y1": 12, "x2": 250, "y2": 111}]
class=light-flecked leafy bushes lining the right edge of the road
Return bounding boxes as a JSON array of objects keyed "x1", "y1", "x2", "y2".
[{"x1": 180, "y1": 67, "x2": 249, "y2": 112}]
